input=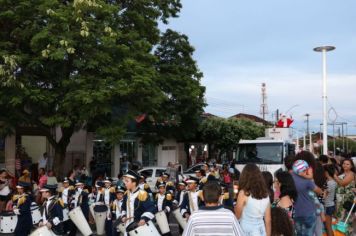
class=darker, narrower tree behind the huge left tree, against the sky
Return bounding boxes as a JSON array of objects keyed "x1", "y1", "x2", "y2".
[{"x1": 140, "y1": 29, "x2": 205, "y2": 143}]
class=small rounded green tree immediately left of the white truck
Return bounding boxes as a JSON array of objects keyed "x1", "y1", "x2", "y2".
[{"x1": 199, "y1": 117, "x2": 264, "y2": 157}]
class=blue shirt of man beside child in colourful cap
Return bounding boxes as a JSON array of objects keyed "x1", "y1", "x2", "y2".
[{"x1": 292, "y1": 173, "x2": 316, "y2": 217}]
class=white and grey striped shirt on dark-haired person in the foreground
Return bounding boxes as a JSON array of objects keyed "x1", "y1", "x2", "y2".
[{"x1": 182, "y1": 206, "x2": 244, "y2": 236}]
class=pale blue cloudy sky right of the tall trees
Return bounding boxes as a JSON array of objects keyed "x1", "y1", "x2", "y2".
[{"x1": 169, "y1": 0, "x2": 356, "y2": 136}]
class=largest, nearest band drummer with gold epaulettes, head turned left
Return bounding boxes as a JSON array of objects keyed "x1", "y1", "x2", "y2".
[{"x1": 121, "y1": 170, "x2": 156, "y2": 230}]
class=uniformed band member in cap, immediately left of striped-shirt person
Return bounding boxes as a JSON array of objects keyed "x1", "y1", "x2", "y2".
[{"x1": 180, "y1": 176, "x2": 202, "y2": 220}]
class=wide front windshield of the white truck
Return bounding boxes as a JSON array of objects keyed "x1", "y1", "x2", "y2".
[{"x1": 236, "y1": 143, "x2": 283, "y2": 164}]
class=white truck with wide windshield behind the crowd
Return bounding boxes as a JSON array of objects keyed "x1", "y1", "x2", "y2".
[{"x1": 235, "y1": 128, "x2": 295, "y2": 175}]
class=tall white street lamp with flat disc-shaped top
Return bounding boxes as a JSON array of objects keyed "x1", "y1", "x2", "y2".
[{"x1": 314, "y1": 46, "x2": 335, "y2": 155}]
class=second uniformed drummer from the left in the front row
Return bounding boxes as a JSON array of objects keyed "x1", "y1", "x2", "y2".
[{"x1": 39, "y1": 184, "x2": 64, "y2": 235}]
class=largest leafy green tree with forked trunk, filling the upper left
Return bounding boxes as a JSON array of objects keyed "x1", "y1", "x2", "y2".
[{"x1": 0, "y1": 0, "x2": 202, "y2": 175}]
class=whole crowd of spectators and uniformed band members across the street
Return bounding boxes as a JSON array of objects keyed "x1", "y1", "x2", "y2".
[{"x1": 0, "y1": 151, "x2": 356, "y2": 236}]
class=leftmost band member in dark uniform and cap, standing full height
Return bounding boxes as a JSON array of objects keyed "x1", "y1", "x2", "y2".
[{"x1": 13, "y1": 182, "x2": 32, "y2": 236}]
